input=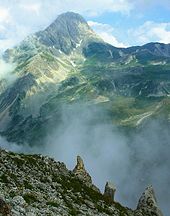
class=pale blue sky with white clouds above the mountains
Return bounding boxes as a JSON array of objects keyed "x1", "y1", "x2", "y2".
[{"x1": 0, "y1": 0, "x2": 170, "y2": 51}]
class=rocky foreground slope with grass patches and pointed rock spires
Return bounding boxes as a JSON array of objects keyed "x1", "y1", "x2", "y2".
[{"x1": 0, "y1": 150, "x2": 162, "y2": 216}]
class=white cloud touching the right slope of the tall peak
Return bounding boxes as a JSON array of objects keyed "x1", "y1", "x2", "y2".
[{"x1": 88, "y1": 21, "x2": 126, "y2": 47}]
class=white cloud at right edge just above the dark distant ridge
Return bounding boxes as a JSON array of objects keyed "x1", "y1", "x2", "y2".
[{"x1": 128, "y1": 21, "x2": 170, "y2": 44}]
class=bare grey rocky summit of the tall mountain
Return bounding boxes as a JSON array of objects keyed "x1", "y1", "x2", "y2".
[{"x1": 37, "y1": 12, "x2": 97, "y2": 54}]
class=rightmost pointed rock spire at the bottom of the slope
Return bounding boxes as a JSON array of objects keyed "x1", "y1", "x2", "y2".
[{"x1": 137, "y1": 186, "x2": 163, "y2": 216}]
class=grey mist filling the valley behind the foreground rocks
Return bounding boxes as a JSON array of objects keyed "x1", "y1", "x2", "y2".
[{"x1": 0, "y1": 105, "x2": 170, "y2": 216}]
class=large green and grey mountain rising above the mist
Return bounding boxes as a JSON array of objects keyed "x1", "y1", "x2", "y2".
[{"x1": 0, "y1": 12, "x2": 170, "y2": 145}]
